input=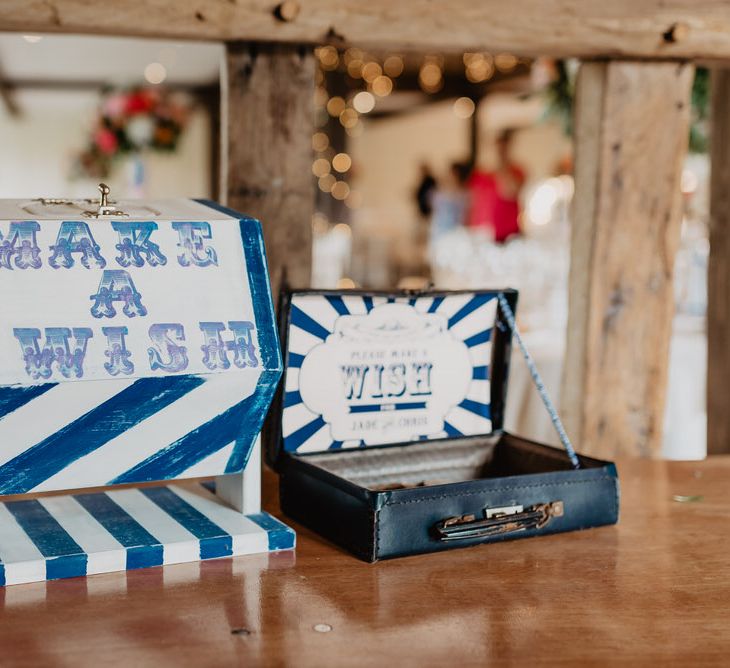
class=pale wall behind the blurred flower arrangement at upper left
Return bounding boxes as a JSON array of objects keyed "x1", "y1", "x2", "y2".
[{"x1": 0, "y1": 90, "x2": 210, "y2": 202}]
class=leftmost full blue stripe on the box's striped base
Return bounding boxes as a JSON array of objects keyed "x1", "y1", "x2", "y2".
[{"x1": 5, "y1": 500, "x2": 87, "y2": 580}]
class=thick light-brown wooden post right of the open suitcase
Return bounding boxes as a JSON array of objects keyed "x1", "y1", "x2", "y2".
[{"x1": 561, "y1": 61, "x2": 694, "y2": 457}]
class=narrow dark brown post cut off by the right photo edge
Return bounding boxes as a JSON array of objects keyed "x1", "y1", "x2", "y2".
[{"x1": 707, "y1": 68, "x2": 730, "y2": 455}]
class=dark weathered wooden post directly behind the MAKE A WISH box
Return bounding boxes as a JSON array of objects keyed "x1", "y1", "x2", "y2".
[{"x1": 221, "y1": 42, "x2": 315, "y2": 297}]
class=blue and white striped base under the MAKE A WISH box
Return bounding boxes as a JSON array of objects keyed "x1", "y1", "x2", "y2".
[{"x1": 0, "y1": 483, "x2": 295, "y2": 585}]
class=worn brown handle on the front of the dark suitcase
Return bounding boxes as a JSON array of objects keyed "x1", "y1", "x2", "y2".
[{"x1": 434, "y1": 501, "x2": 565, "y2": 541}]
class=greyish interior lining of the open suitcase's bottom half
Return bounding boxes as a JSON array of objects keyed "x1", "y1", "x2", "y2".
[{"x1": 307, "y1": 434, "x2": 571, "y2": 490}]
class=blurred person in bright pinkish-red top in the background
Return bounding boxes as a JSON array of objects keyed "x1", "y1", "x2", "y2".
[{"x1": 469, "y1": 128, "x2": 525, "y2": 244}]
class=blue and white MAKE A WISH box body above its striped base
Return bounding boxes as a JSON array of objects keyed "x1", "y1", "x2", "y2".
[{"x1": 0, "y1": 199, "x2": 281, "y2": 494}]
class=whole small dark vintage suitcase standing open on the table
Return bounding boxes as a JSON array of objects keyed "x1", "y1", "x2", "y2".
[{"x1": 265, "y1": 289, "x2": 619, "y2": 561}]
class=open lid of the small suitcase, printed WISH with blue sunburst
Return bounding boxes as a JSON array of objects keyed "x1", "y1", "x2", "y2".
[{"x1": 267, "y1": 289, "x2": 517, "y2": 466}]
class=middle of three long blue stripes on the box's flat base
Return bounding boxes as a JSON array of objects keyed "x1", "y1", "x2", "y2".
[{"x1": 74, "y1": 492, "x2": 163, "y2": 570}]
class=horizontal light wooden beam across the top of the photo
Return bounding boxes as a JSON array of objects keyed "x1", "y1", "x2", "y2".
[{"x1": 0, "y1": 0, "x2": 730, "y2": 60}]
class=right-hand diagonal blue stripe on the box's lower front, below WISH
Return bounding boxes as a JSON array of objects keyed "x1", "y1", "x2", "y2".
[{"x1": 109, "y1": 385, "x2": 271, "y2": 485}]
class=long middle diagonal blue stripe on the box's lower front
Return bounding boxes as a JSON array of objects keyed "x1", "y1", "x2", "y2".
[{"x1": 0, "y1": 376, "x2": 204, "y2": 494}]
